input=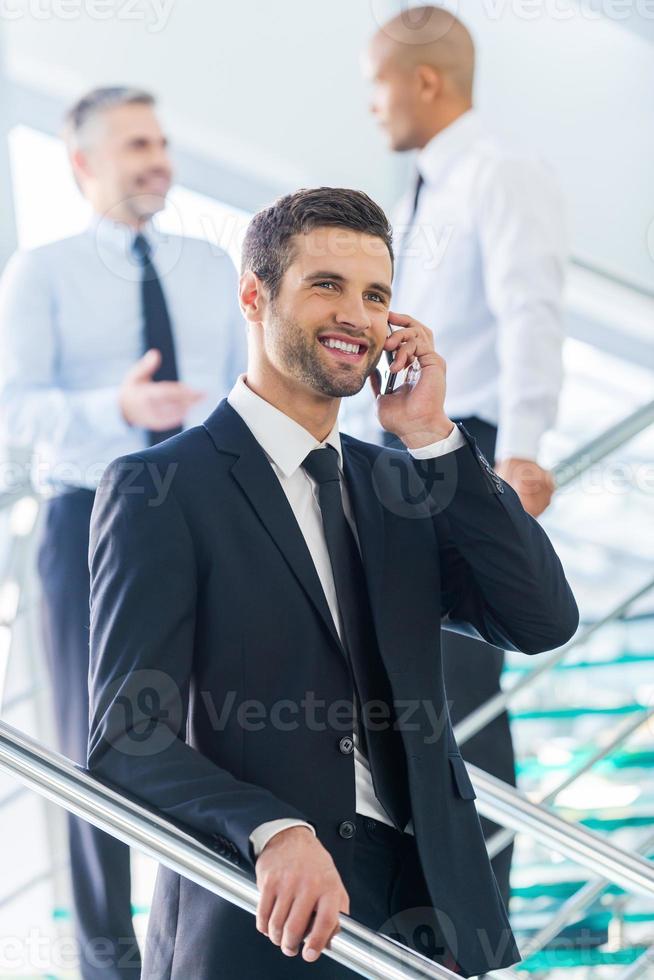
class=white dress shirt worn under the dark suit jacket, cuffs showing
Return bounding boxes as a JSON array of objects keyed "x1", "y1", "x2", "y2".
[{"x1": 227, "y1": 375, "x2": 465, "y2": 856}]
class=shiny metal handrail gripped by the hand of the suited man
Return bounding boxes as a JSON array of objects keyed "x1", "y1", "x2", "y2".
[{"x1": 0, "y1": 722, "x2": 456, "y2": 980}]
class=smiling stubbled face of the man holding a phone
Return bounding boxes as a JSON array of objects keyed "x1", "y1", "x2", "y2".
[{"x1": 249, "y1": 228, "x2": 393, "y2": 398}]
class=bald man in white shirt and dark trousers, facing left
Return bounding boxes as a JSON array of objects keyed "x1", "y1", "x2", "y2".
[{"x1": 354, "y1": 6, "x2": 564, "y2": 912}]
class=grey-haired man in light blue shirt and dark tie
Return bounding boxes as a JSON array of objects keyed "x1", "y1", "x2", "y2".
[{"x1": 0, "y1": 87, "x2": 246, "y2": 980}]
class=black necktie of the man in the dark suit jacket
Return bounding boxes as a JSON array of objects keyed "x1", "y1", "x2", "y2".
[{"x1": 302, "y1": 446, "x2": 411, "y2": 831}]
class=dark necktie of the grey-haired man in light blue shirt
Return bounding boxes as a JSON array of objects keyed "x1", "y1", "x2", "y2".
[{"x1": 134, "y1": 235, "x2": 182, "y2": 446}]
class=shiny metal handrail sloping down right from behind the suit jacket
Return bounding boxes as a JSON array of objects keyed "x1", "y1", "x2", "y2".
[{"x1": 468, "y1": 765, "x2": 654, "y2": 896}]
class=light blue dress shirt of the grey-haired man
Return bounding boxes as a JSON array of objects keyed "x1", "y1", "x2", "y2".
[{"x1": 0, "y1": 218, "x2": 247, "y2": 491}]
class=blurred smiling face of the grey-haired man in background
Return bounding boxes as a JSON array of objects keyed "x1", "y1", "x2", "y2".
[{"x1": 73, "y1": 104, "x2": 172, "y2": 223}]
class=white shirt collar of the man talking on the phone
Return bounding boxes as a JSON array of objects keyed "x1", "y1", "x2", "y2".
[{"x1": 227, "y1": 374, "x2": 343, "y2": 476}]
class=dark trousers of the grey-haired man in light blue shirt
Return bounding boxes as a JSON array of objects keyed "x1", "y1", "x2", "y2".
[{"x1": 38, "y1": 489, "x2": 140, "y2": 980}]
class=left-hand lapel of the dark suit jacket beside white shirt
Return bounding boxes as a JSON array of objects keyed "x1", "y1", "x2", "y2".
[{"x1": 205, "y1": 400, "x2": 345, "y2": 657}]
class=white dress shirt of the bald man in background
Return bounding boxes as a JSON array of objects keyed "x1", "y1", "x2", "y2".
[{"x1": 341, "y1": 110, "x2": 565, "y2": 460}]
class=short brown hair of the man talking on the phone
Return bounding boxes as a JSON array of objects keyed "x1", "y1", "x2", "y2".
[{"x1": 241, "y1": 187, "x2": 394, "y2": 299}]
